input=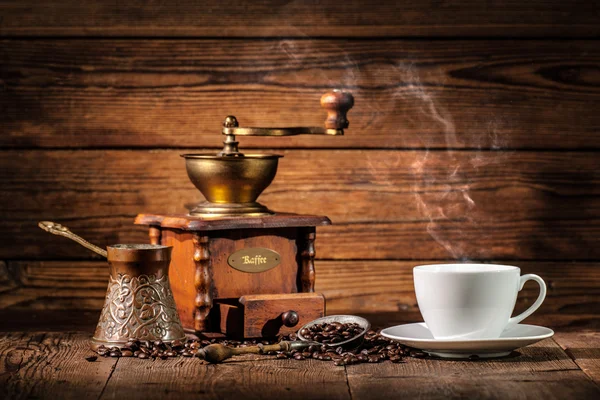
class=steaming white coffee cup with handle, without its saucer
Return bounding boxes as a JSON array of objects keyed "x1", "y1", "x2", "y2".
[{"x1": 413, "y1": 264, "x2": 546, "y2": 340}]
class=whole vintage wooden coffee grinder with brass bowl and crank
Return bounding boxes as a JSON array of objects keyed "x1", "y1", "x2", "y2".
[{"x1": 135, "y1": 90, "x2": 354, "y2": 338}]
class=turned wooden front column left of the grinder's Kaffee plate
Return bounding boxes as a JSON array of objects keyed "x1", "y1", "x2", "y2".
[{"x1": 192, "y1": 233, "x2": 213, "y2": 332}]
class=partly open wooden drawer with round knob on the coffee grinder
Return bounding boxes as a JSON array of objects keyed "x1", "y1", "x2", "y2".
[{"x1": 213, "y1": 293, "x2": 325, "y2": 338}]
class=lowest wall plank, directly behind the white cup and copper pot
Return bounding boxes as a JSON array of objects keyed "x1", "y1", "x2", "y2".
[{"x1": 0, "y1": 260, "x2": 600, "y2": 330}]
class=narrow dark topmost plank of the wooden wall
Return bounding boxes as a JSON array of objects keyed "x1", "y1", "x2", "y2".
[{"x1": 0, "y1": 0, "x2": 600, "y2": 37}]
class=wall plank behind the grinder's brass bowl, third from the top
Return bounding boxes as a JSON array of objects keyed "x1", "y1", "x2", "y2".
[{"x1": 0, "y1": 150, "x2": 600, "y2": 260}]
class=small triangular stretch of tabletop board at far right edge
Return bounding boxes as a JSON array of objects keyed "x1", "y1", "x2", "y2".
[{"x1": 554, "y1": 330, "x2": 600, "y2": 387}]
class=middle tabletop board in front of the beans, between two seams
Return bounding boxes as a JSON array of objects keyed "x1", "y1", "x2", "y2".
[{"x1": 100, "y1": 356, "x2": 350, "y2": 399}]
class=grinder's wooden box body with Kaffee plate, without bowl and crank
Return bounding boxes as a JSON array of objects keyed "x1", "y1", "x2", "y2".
[{"x1": 136, "y1": 214, "x2": 331, "y2": 338}]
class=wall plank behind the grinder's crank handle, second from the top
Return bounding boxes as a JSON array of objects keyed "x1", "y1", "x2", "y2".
[{"x1": 0, "y1": 39, "x2": 600, "y2": 150}]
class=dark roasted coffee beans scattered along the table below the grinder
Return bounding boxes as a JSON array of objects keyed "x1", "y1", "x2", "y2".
[{"x1": 92, "y1": 323, "x2": 427, "y2": 366}]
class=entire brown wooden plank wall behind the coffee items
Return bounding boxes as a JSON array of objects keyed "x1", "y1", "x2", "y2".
[{"x1": 0, "y1": 0, "x2": 600, "y2": 327}]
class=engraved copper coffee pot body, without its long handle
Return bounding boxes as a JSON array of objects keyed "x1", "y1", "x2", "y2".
[{"x1": 91, "y1": 244, "x2": 185, "y2": 350}]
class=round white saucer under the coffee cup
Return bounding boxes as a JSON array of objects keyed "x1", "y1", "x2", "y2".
[{"x1": 381, "y1": 322, "x2": 554, "y2": 358}]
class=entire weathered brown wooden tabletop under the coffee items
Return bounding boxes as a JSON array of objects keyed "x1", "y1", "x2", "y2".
[{"x1": 0, "y1": 315, "x2": 600, "y2": 400}]
